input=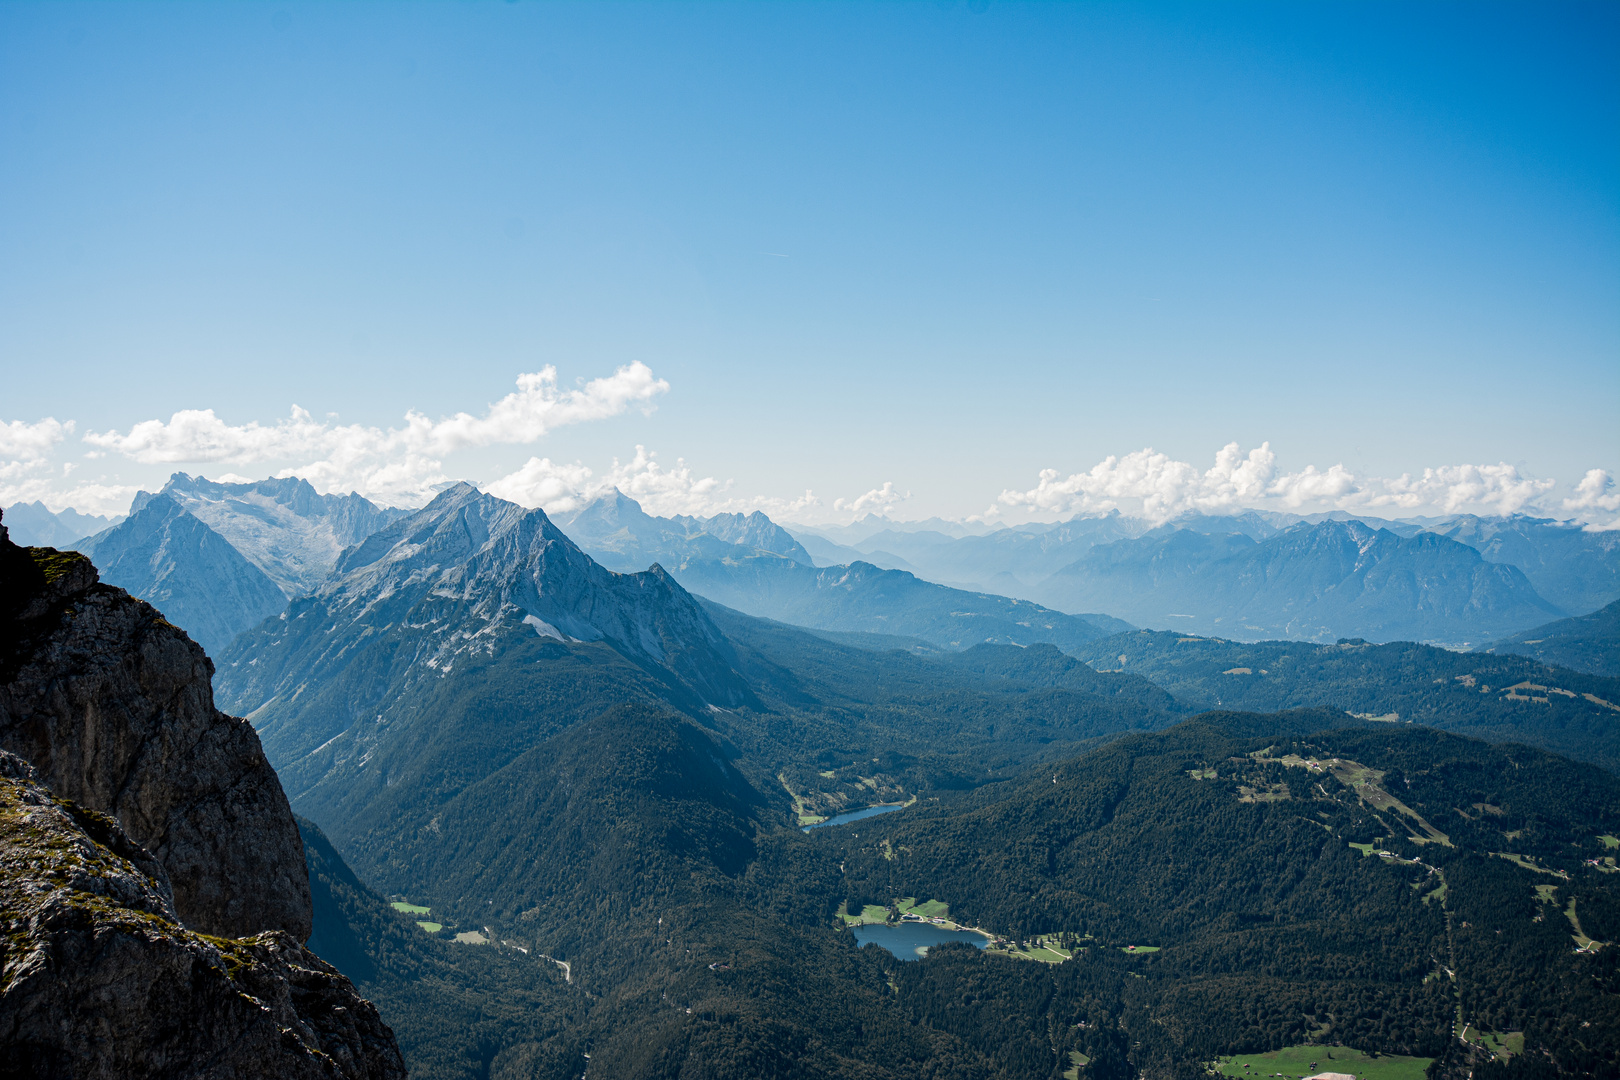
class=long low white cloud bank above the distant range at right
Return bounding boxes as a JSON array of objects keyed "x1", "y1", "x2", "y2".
[{"x1": 985, "y1": 442, "x2": 1587, "y2": 523}]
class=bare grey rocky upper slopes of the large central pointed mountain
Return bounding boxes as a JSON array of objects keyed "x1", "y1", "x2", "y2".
[{"x1": 222, "y1": 484, "x2": 748, "y2": 731}]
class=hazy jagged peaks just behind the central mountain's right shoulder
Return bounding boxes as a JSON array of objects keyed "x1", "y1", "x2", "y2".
[{"x1": 556, "y1": 491, "x2": 812, "y2": 572}]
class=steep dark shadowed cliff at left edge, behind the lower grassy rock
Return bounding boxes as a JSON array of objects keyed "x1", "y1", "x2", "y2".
[{"x1": 0, "y1": 526, "x2": 309, "y2": 941}]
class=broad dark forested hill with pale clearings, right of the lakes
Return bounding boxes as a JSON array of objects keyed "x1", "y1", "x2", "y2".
[{"x1": 812, "y1": 712, "x2": 1620, "y2": 1075}]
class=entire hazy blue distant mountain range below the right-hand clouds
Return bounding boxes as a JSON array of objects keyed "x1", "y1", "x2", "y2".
[{"x1": 795, "y1": 510, "x2": 1620, "y2": 644}]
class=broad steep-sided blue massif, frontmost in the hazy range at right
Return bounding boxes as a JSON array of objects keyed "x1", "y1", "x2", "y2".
[{"x1": 1043, "y1": 521, "x2": 1560, "y2": 643}]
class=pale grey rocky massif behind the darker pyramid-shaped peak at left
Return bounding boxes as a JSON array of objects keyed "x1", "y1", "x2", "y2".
[{"x1": 131, "y1": 473, "x2": 408, "y2": 595}]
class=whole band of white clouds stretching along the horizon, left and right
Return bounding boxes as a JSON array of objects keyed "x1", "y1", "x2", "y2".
[{"x1": 0, "y1": 361, "x2": 1620, "y2": 528}]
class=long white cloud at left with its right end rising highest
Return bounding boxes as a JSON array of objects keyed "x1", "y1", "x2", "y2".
[{"x1": 84, "y1": 361, "x2": 669, "y2": 502}]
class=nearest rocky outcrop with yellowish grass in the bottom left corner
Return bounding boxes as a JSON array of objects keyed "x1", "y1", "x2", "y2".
[{"x1": 0, "y1": 751, "x2": 405, "y2": 1080}]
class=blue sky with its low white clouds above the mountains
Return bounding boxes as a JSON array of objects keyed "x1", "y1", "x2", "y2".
[{"x1": 0, "y1": 0, "x2": 1620, "y2": 520}]
